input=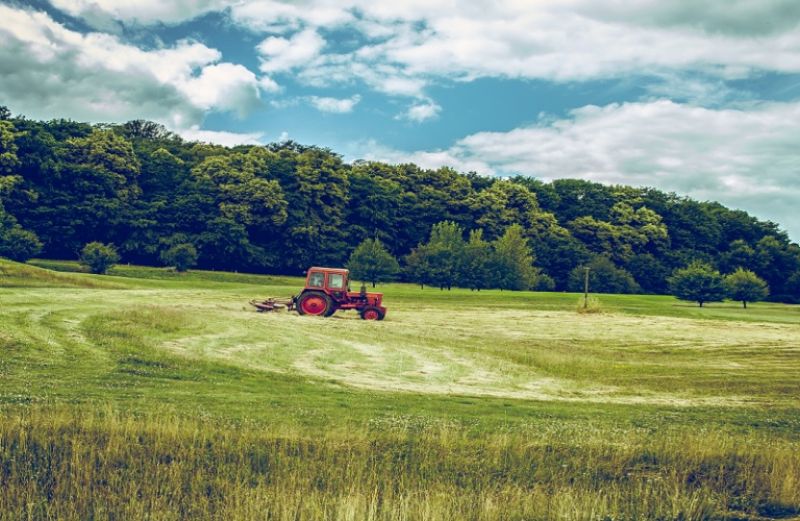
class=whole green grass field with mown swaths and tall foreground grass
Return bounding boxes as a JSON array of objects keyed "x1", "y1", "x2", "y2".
[{"x1": 0, "y1": 261, "x2": 800, "y2": 520}]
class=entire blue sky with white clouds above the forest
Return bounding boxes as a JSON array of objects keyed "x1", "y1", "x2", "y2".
[{"x1": 0, "y1": 0, "x2": 800, "y2": 241}]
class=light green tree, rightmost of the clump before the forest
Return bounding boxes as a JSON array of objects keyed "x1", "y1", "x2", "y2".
[{"x1": 494, "y1": 224, "x2": 537, "y2": 290}]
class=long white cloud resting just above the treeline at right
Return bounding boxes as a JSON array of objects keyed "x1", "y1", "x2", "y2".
[{"x1": 362, "y1": 100, "x2": 800, "y2": 239}]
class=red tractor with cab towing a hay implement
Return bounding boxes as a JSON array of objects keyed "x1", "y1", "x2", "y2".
[{"x1": 250, "y1": 267, "x2": 386, "y2": 320}]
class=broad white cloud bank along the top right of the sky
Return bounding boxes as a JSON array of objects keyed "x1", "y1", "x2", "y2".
[{"x1": 227, "y1": 0, "x2": 800, "y2": 98}]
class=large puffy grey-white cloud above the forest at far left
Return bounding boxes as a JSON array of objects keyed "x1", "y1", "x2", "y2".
[{"x1": 0, "y1": 5, "x2": 264, "y2": 129}]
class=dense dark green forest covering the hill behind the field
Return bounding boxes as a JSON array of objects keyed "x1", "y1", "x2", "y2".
[{"x1": 0, "y1": 107, "x2": 800, "y2": 302}]
